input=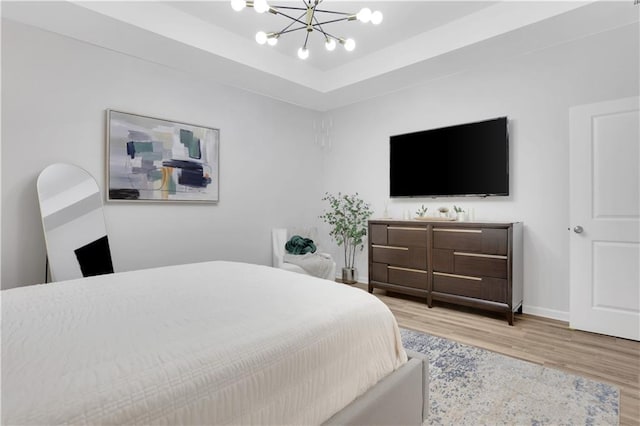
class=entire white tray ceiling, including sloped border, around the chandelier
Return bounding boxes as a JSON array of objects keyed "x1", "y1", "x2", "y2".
[{"x1": 1, "y1": 0, "x2": 640, "y2": 110}]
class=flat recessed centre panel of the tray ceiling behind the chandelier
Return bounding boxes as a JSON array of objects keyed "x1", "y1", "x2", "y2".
[{"x1": 167, "y1": 0, "x2": 495, "y2": 71}]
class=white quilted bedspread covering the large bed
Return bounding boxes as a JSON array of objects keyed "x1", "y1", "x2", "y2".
[{"x1": 2, "y1": 262, "x2": 407, "y2": 425}]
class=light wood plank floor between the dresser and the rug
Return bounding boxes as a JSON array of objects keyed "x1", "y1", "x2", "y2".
[{"x1": 357, "y1": 284, "x2": 640, "y2": 425}]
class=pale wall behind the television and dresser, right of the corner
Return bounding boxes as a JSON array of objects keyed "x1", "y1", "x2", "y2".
[{"x1": 324, "y1": 20, "x2": 640, "y2": 319}]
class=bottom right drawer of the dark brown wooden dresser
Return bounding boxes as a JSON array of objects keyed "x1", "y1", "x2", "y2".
[{"x1": 433, "y1": 272, "x2": 507, "y2": 303}]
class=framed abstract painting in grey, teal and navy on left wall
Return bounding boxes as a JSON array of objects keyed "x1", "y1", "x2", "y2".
[{"x1": 107, "y1": 110, "x2": 220, "y2": 203}]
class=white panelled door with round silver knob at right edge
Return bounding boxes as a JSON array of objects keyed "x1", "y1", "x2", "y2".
[{"x1": 569, "y1": 97, "x2": 640, "y2": 340}]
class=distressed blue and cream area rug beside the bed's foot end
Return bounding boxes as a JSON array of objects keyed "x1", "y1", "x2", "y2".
[{"x1": 400, "y1": 329, "x2": 619, "y2": 425}]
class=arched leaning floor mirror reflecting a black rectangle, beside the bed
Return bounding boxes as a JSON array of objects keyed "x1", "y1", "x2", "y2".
[{"x1": 37, "y1": 163, "x2": 113, "y2": 281}]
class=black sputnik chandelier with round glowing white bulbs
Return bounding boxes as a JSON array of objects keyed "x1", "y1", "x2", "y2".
[{"x1": 231, "y1": 0, "x2": 382, "y2": 59}]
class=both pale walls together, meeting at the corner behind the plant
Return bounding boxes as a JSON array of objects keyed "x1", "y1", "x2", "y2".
[{"x1": 1, "y1": 18, "x2": 639, "y2": 319}]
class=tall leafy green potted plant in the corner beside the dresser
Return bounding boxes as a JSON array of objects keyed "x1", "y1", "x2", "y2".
[{"x1": 320, "y1": 192, "x2": 373, "y2": 284}]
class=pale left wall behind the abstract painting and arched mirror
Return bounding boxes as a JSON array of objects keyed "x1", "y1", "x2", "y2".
[{"x1": 1, "y1": 21, "x2": 322, "y2": 288}]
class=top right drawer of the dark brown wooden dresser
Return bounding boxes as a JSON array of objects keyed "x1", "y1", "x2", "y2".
[{"x1": 433, "y1": 227, "x2": 508, "y2": 255}]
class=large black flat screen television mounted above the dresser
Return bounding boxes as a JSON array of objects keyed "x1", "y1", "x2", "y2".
[{"x1": 389, "y1": 117, "x2": 509, "y2": 197}]
